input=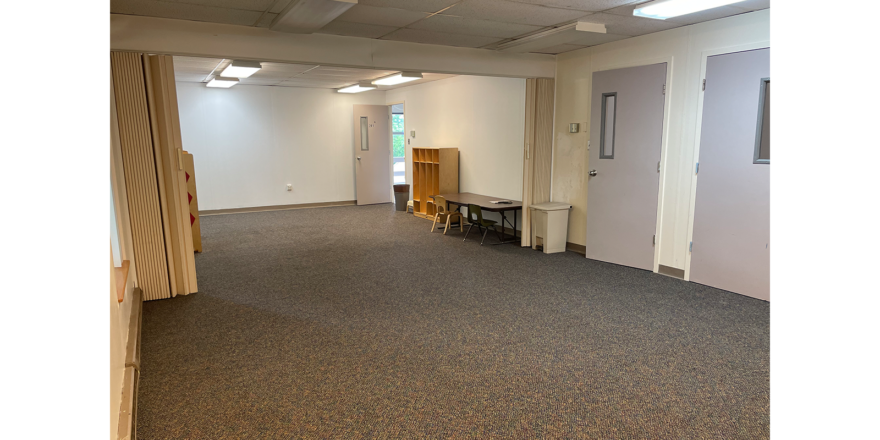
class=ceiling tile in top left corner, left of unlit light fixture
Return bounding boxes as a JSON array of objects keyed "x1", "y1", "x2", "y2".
[{"x1": 110, "y1": 0, "x2": 263, "y2": 26}]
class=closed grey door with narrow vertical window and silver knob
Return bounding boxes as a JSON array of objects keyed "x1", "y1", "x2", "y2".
[{"x1": 587, "y1": 63, "x2": 666, "y2": 270}]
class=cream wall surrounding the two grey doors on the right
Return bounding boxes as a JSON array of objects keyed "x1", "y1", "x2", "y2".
[{"x1": 553, "y1": 9, "x2": 772, "y2": 271}]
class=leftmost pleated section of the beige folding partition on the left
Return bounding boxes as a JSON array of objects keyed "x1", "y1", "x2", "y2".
[{"x1": 110, "y1": 52, "x2": 171, "y2": 300}]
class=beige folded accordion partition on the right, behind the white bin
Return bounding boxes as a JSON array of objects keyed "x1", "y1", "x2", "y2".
[{"x1": 522, "y1": 79, "x2": 556, "y2": 246}]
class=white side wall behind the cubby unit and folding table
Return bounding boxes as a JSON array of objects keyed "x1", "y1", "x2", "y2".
[{"x1": 386, "y1": 76, "x2": 526, "y2": 227}]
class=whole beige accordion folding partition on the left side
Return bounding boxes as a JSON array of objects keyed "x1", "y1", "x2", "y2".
[{"x1": 110, "y1": 52, "x2": 198, "y2": 301}]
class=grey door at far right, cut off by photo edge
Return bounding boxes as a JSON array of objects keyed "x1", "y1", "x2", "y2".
[{"x1": 691, "y1": 49, "x2": 773, "y2": 301}]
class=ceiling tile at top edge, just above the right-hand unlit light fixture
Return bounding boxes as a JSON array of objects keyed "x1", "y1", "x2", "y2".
[{"x1": 444, "y1": 0, "x2": 590, "y2": 26}]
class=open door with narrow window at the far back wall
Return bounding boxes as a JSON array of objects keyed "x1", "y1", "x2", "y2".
[{"x1": 354, "y1": 105, "x2": 392, "y2": 206}]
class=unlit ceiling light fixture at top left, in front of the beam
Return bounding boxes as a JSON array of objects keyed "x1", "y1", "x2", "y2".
[{"x1": 269, "y1": 0, "x2": 358, "y2": 34}]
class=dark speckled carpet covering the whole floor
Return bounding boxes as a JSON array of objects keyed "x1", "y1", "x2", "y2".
[{"x1": 138, "y1": 206, "x2": 772, "y2": 440}]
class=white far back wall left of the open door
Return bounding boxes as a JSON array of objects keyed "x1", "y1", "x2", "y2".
[{"x1": 177, "y1": 83, "x2": 385, "y2": 211}]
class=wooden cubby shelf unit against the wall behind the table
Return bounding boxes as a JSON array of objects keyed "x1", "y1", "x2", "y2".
[{"x1": 412, "y1": 148, "x2": 459, "y2": 220}]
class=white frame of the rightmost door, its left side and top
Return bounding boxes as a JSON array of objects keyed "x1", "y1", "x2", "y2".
[{"x1": 684, "y1": 40, "x2": 773, "y2": 282}]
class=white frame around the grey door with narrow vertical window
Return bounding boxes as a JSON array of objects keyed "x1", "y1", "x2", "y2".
[{"x1": 584, "y1": 55, "x2": 675, "y2": 273}]
